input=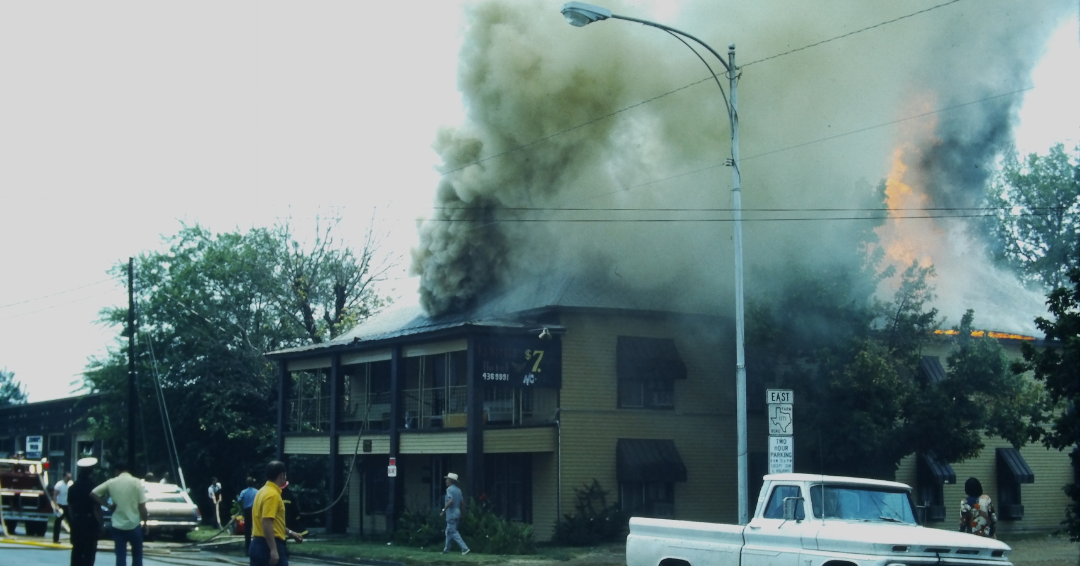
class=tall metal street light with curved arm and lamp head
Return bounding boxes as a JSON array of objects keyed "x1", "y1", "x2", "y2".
[{"x1": 562, "y1": 2, "x2": 750, "y2": 525}]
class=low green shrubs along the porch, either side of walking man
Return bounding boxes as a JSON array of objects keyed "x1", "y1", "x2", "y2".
[{"x1": 394, "y1": 499, "x2": 536, "y2": 554}]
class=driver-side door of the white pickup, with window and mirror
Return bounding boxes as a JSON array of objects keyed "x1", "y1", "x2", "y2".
[{"x1": 741, "y1": 485, "x2": 807, "y2": 566}]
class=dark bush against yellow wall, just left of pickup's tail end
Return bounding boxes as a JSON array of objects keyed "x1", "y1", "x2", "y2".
[{"x1": 553, "y1": 477, "x2": 630, "y2": 547}]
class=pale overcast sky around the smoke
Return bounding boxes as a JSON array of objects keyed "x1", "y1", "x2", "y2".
[{"x1": 0, "y1": 0, "x2": 1080, "y2": 402}]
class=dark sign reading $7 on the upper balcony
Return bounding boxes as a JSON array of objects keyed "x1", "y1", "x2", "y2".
[{"x1": 474, "y1": 336, "x2": 563, "y2": 389}]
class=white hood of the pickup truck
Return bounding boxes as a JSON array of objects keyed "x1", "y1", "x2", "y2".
[{"x1": 816, "y1": 520, "x2": 1011, "y2": 562}]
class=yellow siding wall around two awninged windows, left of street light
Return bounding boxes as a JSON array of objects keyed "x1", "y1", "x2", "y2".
[{"x1": 557, "y1": 314, "x2": 734, "y2": 528}]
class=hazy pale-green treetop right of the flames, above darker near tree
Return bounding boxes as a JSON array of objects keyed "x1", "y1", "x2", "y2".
[{"x1": 987, "y1": 144, "x2": 1080, "y2": 289}]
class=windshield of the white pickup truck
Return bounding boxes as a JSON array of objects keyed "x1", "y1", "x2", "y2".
[{"x1": 810, "y1": 485, "x2": 915, "y2": 525}]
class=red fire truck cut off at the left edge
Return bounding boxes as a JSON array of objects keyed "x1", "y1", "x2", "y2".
[{"x1": 0, "y1": 454, "x2": 56, "y2": 537}]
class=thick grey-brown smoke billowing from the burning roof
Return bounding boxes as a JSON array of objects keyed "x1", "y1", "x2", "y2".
[{"x1": 413, "y1": 0, "x2": 1075, "y2": 332}]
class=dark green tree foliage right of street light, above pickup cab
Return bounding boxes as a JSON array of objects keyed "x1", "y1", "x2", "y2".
[{"x1": 747, "y1": 211, "x2": 1041, "y2": 479}]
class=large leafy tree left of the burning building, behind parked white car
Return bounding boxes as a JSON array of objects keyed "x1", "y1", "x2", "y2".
[{"x1": 85, "y1": 218, "x2": 390, "y2": 522}]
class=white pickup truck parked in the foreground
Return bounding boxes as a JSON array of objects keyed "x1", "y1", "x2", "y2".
[{"x1": 626, "y1": 473, "x2": 1012, "y2": 566}]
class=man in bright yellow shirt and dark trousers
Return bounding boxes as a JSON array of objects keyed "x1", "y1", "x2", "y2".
[{"x1": 247, "y1": 460, "x2": 303, "y2": 566}]
